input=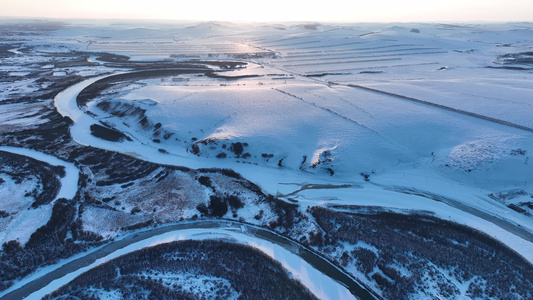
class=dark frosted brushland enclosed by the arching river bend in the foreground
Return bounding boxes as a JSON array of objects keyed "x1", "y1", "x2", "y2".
[{"x1": 45, "y1": 241, "x2": 315, "y2": 299}]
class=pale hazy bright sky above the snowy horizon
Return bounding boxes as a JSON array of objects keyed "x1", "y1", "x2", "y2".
[{"x1": 0, "y1": 0, "x2": 533, "y2": 23}]
